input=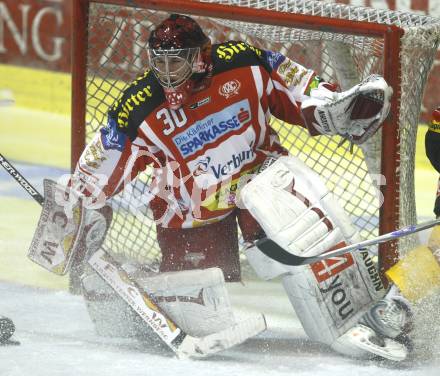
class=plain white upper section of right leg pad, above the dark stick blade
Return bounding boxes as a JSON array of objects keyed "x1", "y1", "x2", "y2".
[{"x1": 240, "y1": 156, "x2": 359, "y2": 256}]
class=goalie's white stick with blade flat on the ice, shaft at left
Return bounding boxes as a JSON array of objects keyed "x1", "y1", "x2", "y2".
[{"x1": 0, "y1": 155, "x2": 267, "y2": 358}]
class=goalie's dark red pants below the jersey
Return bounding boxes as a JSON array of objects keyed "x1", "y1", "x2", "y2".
[{"x1": 157, "y1": 208, "x2": 264, "y2": 282}]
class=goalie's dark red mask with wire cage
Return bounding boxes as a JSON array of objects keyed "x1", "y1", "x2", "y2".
[{"x1": 148, "y1": 14, "x2": 212, "y2": 110}]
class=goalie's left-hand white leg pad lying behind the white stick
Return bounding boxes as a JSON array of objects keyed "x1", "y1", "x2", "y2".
[{"x1": 82, "y1": 268, "x2": 235, "y2": 337}]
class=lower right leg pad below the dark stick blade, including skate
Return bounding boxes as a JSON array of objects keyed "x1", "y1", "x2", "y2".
[{"x1": 246, "y1": 247, "x2": 411, "y2": 361}]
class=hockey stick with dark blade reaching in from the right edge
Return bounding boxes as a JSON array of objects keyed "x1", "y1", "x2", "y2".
[{"x1": 256, "y1": 219, "x2": 440, "y2": 266}]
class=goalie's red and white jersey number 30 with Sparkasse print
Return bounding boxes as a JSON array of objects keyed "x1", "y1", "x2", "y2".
[{"x1": 72, "y1": 42, "x2": 320, "y2": 228}]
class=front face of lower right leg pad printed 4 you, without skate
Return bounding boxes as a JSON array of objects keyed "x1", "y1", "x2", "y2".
[{"x1": 282, "y1": 247, "x2": 384, "y2": 345}]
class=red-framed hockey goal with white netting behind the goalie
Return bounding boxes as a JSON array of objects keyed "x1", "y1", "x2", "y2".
[{"x1": 72, "y1": 0, "x2": 440, "y2": 276}]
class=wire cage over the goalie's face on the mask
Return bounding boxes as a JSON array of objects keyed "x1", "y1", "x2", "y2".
[{"x1": 147, "y1": 47, "x2": 200, "y2": 89}]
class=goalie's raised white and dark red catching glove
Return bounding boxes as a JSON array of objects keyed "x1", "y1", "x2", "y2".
[{"x1": 301, "y1": 75, "x2": 393, "y2": 144}]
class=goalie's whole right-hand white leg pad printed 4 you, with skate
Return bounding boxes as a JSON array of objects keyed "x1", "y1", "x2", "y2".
[{"x1": 241, "y1": 157, "x2": 407, "y2": 360}]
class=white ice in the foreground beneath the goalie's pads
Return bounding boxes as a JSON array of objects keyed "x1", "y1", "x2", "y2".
[{"x1": 0, "y1": 281, "x2": 440, "y2": 376}]
